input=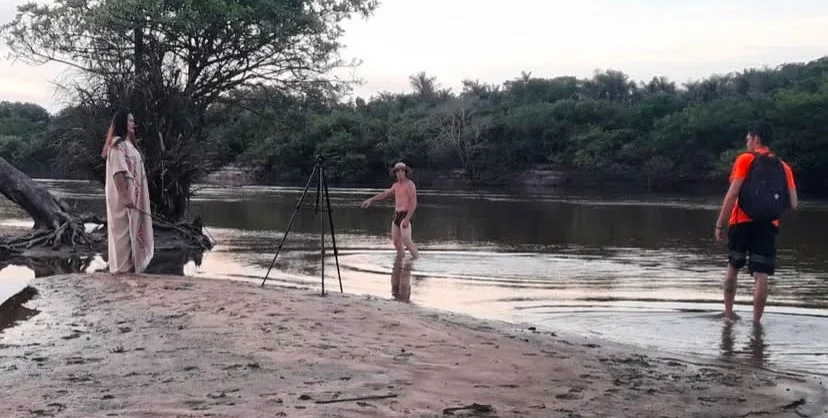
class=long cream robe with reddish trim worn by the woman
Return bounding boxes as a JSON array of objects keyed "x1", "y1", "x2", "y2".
[{"x1": 106, "y1": 138, "x2": 155, "y2": 273}]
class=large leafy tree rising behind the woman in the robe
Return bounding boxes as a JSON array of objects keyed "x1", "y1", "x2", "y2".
[{"x1": 2, "y1": 0, "x2": 377, "y2": 219}]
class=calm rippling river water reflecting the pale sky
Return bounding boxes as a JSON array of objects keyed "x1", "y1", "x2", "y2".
[{"x1": 0, "y1": 181, "x2": 828, "y2": 375}]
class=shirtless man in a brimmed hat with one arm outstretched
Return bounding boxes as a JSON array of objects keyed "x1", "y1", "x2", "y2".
[{"x1": 360, "y1": 162, "x2": 418, "y2": 258}]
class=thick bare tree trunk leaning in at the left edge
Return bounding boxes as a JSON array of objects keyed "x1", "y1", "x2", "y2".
[{"x1": 0, "y1": 157, "x2": 72, "y2": 230}]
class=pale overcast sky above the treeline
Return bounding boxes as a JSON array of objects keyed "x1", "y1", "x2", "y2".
[{"x1": 0, "y1": 0, "x2": 828, "y2": 111}]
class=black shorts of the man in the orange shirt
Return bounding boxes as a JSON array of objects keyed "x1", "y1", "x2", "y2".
[{"x1": 727, "y1": 222, "x2": 779, "y2": 276}]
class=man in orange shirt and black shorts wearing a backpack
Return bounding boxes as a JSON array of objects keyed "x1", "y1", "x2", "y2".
[{"x1": 715, "y1": 121, "x2": 799, "y2": 324}]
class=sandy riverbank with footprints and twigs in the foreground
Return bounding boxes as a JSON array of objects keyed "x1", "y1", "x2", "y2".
[{"x1": 0, "y1": 274, "x2": 828, "y2": 417}]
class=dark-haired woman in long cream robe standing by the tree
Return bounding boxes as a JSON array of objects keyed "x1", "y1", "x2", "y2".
[{"x1": 101, "y1": 111, "x2": 155, "y2": 273}]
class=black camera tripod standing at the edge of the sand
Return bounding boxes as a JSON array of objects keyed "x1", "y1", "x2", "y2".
[{"x1": 262, "y1": 155, "x2": 343, "y2": 296}]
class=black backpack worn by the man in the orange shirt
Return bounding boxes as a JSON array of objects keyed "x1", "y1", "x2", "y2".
[{"x1": 739, "y1": 152, "x2": 790, "y2": 222}]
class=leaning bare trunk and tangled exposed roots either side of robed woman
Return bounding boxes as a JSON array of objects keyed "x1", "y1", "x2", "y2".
[{"x1": 0, "y1": 157, "x2": 214, "y2": 262}]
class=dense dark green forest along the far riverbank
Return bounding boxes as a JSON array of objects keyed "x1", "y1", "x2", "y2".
[{"x1": 0, "y1": 57, "x2": 828, "y2": 194}]
